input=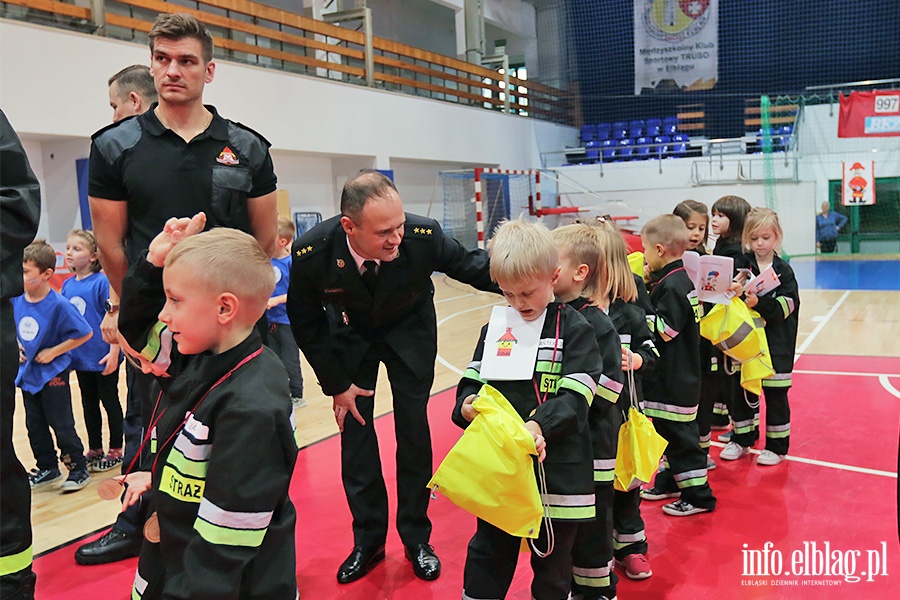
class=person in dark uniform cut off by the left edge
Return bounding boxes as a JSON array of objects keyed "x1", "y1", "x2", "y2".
[{"x1": 0, "y1": 110, "x2": 41, "y2": 600}]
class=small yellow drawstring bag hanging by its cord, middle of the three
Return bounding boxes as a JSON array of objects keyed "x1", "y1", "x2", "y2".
[{"x1": 613, "y1": 371, "x2": 669, "y2": 492}]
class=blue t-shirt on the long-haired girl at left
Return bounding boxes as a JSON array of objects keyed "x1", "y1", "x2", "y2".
[{"x1": 62, "y1": 273, "x2": 121, "y2": 371}]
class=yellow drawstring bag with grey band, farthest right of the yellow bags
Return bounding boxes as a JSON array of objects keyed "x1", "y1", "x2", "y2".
[{"x1": 700, "y1": 297, "x2": 775, "y2": 395}]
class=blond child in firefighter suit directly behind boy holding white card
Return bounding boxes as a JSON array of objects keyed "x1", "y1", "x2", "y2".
[{"x1": 553, "y1": 223, "x2": 623, "y2": 600}]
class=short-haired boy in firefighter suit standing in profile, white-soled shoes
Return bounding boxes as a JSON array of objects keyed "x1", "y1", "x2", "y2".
[{"x1": 641, "y1": 215, "x2": 716, "y2": 517}]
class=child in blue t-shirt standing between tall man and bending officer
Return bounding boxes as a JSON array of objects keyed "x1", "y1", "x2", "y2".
[{"x1": 266, "y1": 217, "x2": 306, "y2": 408}]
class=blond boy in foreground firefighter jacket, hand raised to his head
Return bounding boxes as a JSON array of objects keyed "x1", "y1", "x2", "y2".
[{"x1": 118, "y1": 213, "x2": 297, "y2": 600}]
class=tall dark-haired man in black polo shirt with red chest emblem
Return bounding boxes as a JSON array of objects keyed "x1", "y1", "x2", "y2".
[{"x1": 76, "y1": 14, "x2": 277, "y2": 564}]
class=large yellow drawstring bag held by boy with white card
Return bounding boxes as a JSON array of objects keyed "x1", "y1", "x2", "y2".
[{"x1": 428, "y1": 384, "x2": 544, "y2": 538}]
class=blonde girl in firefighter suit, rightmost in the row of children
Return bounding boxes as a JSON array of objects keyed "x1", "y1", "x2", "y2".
[{"x1": 722, "y1": 207, "x2": 800, "y2": 466}]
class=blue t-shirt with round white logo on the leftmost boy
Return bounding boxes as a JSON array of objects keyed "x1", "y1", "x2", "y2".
[{"x1": 13, "y1": 290, "x2": 91, "y2": 394}]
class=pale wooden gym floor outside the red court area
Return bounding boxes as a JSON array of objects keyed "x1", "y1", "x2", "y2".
[{"x1": 14, "y1": 275, "x2": 900, "y2": 554}]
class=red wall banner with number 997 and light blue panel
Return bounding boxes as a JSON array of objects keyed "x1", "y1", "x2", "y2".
[{"x1": 838, "y1": 90, "x2": 900, "y2": 137}]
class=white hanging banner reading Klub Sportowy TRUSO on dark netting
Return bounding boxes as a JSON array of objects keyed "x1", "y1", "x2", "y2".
[{"x1": 634, "y1": 0, "x2": 719, "y2": 95}]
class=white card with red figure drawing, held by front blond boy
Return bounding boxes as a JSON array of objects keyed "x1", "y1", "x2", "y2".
[{"x1": 481, "y1": 306, "x2": 547, "y2": 381}]
